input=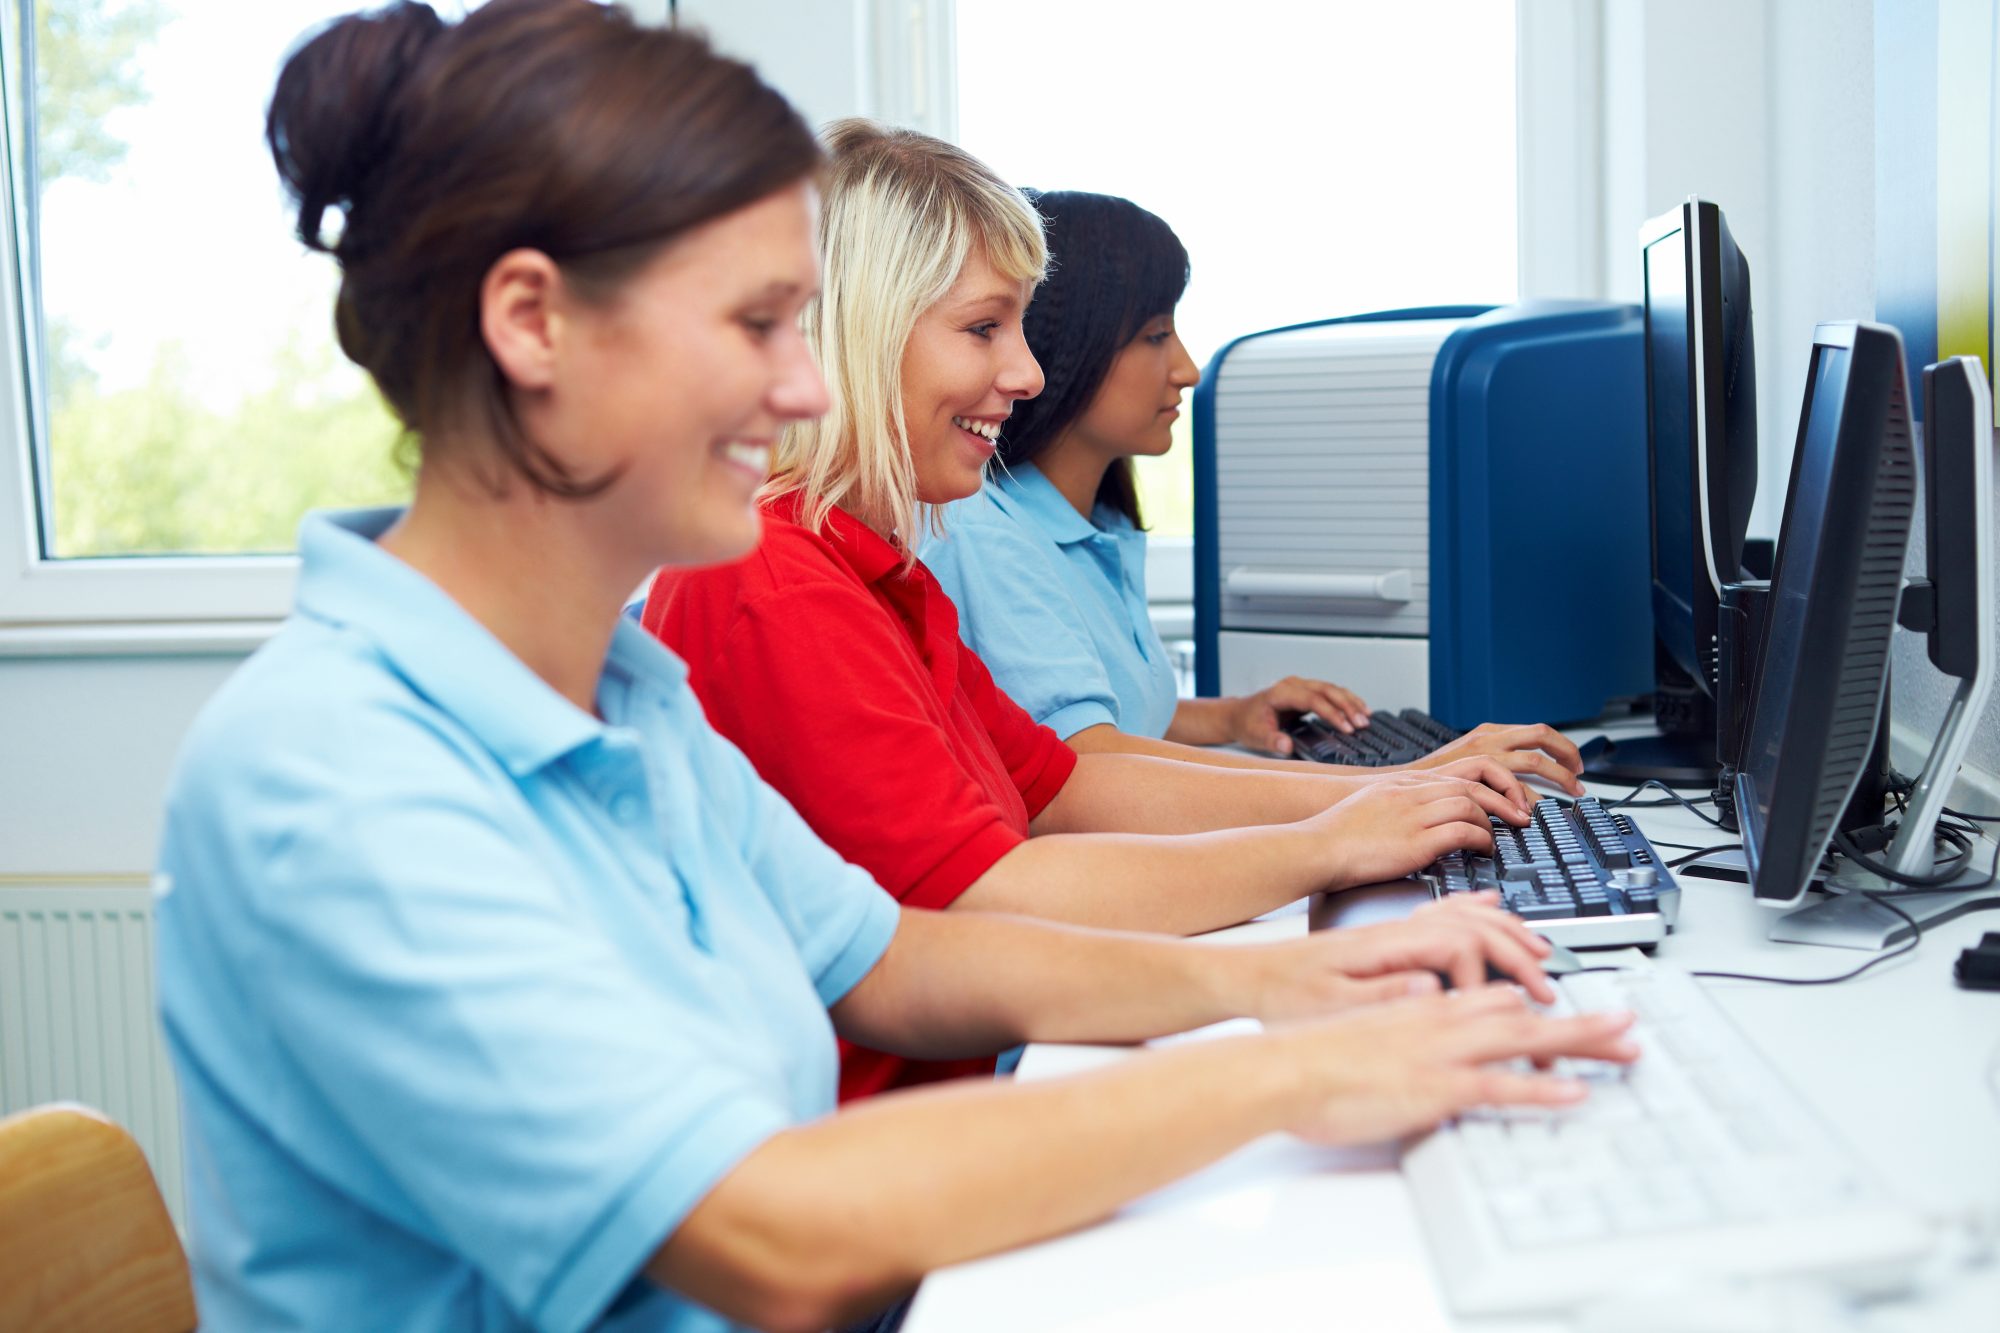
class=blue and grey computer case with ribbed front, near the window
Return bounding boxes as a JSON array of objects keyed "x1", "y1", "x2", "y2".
[{"x1": 1194, "y1": 302, "x2": 1652, "y2": 727}]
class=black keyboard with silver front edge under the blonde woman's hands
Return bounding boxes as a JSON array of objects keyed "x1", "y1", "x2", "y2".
[{"x1": 1420, "y1": 797, "x2": 1680, "y2": 949}]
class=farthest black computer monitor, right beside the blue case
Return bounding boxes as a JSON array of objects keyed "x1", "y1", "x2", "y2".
[{"x1": 1590, "y1": 198, "x2": 1756, "y2": 787}]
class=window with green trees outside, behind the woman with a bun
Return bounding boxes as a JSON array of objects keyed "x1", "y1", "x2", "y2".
[{"x1": 0, "y1": 0, "x2": 426, "y2": 620}]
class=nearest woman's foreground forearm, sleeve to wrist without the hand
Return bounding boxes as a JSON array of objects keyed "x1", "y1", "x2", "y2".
[{"x1": 648, "y1": 1037, "x2": 1310, "y2": 1329}]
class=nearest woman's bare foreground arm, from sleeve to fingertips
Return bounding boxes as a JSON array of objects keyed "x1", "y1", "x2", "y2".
[{"x1": 646, "y1": 987, "x2": 1636, "y2": 1333}]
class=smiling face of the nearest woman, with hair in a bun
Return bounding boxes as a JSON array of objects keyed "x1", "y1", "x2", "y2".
[{"x1": 546, "y1": 184, "x2": 826, "y2": 564}]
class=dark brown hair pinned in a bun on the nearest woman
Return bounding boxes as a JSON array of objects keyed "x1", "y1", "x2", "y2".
[{"x1": 264, "y1": 0, "x2": 820, "y2": 498}]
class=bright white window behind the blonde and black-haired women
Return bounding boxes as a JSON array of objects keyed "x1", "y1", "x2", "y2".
[{"x1": 956, "y1": 0, "x2": 1516, "y2": 536}]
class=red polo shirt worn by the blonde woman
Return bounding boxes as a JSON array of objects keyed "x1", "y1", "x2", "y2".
[{"x1": 644, "y1": 494, "x2": 1076, "y2": 1101}]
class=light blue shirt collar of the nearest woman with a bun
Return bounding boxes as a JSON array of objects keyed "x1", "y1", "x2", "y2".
[{"x1": 298, "y1": 508, "x2": 688, "y2": 777}]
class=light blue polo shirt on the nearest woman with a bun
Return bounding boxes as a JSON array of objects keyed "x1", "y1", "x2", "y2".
[{"x1": 158, "y1": 510, "x2": 898, "y2": 1333}]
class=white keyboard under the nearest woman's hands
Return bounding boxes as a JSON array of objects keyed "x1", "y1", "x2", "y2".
[{"x1": 1402, "y1": 967, "x2": 1932, "y2": 1315}]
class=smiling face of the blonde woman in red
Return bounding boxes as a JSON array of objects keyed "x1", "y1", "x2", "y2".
[{"x1": 902, "y1": 250, "x2": 1042, "y2": 504}]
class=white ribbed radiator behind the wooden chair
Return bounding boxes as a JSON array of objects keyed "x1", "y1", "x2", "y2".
[{"x1": 0, "y1": 879, "x2": 184, "y2": 1225}]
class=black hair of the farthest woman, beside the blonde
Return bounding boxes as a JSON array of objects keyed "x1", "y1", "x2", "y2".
[{"x1": 1000, "y1": 190, "x2": 1188, "y2": 526}]
